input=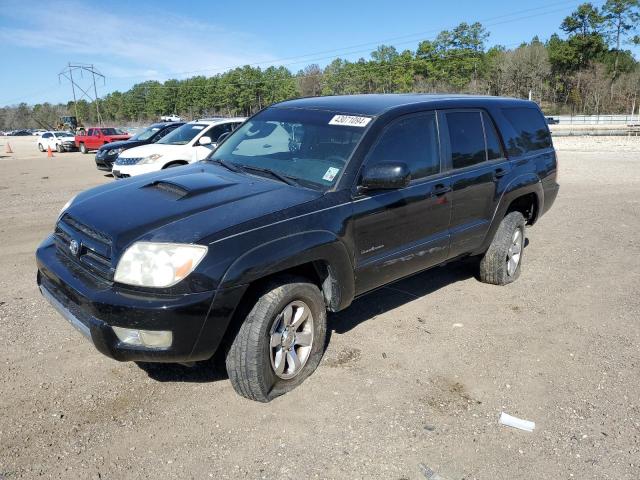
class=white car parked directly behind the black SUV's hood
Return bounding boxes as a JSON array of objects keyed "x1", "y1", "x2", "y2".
[{"x1": 112, "y1": 117, "x2": 245, "y2": 178}]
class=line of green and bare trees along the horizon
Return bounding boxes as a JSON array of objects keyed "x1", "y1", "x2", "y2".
[{"x1": 0, "y1": 0, "x2": 640, "y2": 129}]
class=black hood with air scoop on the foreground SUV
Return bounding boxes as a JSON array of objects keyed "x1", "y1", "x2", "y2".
[{"x1": 66, "y1": 162, "x2": 322, "y2": 257}]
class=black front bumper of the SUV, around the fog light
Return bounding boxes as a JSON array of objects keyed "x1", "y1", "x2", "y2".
[{"x1": 36, "y1": 237, "x2": 245, "y2": 362}]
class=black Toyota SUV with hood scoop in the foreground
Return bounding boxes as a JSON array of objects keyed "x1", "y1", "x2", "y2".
[{"x1": 36, "y1": 95, "x2": 558, "y2": 401}]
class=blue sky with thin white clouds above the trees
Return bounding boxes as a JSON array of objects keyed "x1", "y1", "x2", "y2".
[{"x1": 0, "y1": 0, "x2": 639, "y2": 105}]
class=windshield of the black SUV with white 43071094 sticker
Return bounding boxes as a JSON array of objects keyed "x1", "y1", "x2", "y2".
[{"x1": 209, "y1": 108, "x2": 371, "y2": 190}]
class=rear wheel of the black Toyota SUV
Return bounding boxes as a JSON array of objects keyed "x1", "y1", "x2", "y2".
[{"x1": 480, "y1": 212, "x2": 526, "y2": 285}]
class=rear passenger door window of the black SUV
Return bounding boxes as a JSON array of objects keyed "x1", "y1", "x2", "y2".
[{"x1": 446, "y1": 111, "x2": 487, "y2": 169}]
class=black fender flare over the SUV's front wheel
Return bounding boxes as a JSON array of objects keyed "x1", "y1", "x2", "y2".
[{"x1": 220, "y1": 230, "x2": 355, "y2": 311}]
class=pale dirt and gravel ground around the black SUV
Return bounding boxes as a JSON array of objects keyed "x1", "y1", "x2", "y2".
[{"x1": 0, "y1": 132, "x2": 640, "y2": 480}]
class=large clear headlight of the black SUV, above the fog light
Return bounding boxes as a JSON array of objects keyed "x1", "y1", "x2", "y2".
[{"x1": 114, "y1": 242, "x2": 208, "y2": 287}]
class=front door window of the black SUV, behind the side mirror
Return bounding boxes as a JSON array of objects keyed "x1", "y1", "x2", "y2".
[{"x1": 367, "y1": 112, "x2": 440, "y2": 180}]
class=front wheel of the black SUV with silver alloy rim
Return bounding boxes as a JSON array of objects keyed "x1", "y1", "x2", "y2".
[{"x1": 226, "y1": 276, "x2": 327, "y2": 402}]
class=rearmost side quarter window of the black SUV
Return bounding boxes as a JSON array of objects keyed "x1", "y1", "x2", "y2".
[{"x1": 502, "y1": 107, "x2": 551, "y2": 155}]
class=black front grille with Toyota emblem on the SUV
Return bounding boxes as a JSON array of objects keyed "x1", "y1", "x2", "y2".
[{"x1": 55, "y1": 214, "x2": 114, "y2": 280}]
